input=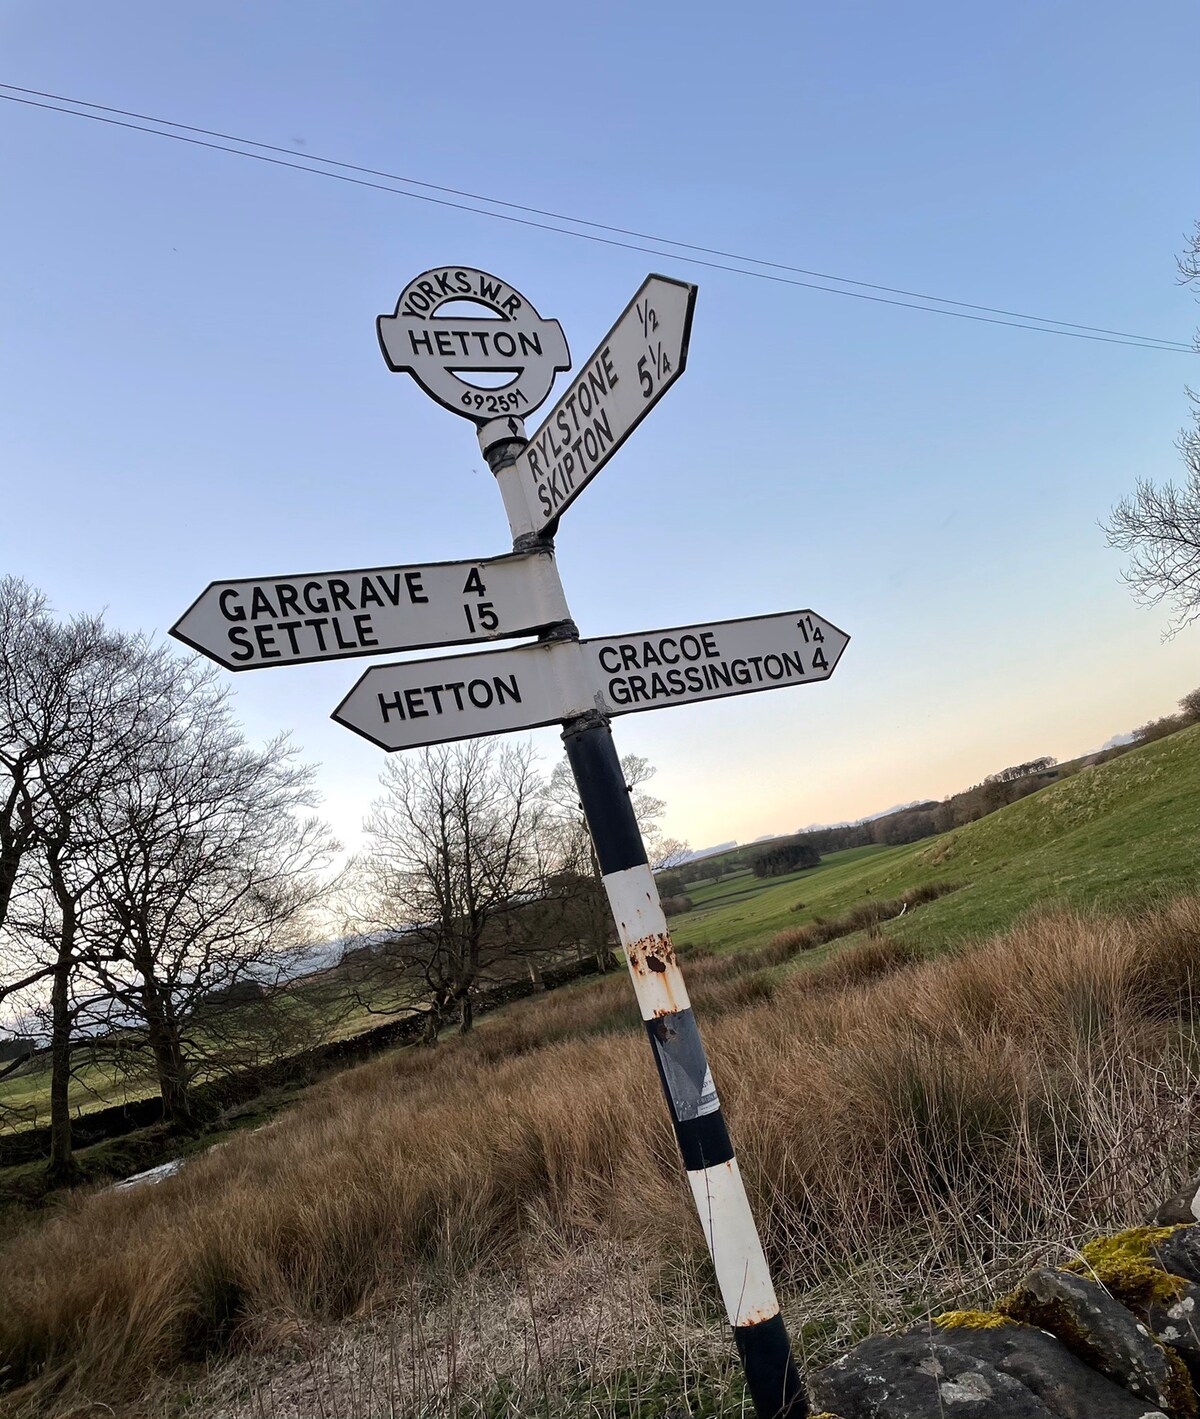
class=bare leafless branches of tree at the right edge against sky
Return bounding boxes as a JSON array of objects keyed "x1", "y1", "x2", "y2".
[{"x1": 1102, "y1": 221, "x2": 1200, "y2": 637}]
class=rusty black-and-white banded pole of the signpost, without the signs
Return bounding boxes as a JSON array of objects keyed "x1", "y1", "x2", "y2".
[{"x1": 479, "y1": 420, "x2": 809, "y2": 1419}]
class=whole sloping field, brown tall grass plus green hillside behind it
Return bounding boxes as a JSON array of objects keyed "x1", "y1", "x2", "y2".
[{"x1": 0, "y1": 727, "x2": 1200, "y2": 1419}]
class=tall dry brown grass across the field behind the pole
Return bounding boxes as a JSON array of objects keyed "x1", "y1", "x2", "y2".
[{"x1": 0, "y1": 898, "x2": 1200, "y2": 1415}]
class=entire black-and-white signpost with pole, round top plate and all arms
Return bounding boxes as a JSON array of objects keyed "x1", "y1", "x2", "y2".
[{"x1": 172, "y1": 267, "x2": 850, "y2": 1419}]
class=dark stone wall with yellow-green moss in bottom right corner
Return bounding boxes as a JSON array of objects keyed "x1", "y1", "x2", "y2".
[{"x1": 809, "y1": 1186, "x2": 1200, "y2": 1419}]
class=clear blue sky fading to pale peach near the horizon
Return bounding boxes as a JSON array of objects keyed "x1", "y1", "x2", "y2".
[{"x1": 0, "y1": 0, "x2": 1200, "y2": 846}]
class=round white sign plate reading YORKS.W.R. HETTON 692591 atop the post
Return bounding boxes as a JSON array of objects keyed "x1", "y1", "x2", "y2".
[{"x1": 376, "y1": 267, "x2": 570, "y2": 424}]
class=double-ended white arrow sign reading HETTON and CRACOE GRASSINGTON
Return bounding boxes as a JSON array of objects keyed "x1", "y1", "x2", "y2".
[{"x1": 333, "y1": 610, "x2": 850, "y2": 749}]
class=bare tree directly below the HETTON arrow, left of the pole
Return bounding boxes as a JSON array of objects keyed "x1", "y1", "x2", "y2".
[{"x1": 352, "y1": 739, "x2": 552, "y2": 1044}]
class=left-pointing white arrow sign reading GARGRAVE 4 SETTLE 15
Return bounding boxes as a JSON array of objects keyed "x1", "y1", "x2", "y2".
[{"x1": 170, "y1": 552, "x2": 567, "y2": 670}]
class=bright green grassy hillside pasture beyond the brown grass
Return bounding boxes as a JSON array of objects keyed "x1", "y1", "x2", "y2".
[{"x1": 671, "y1": 725, "x2": 1200, "y2": 951}]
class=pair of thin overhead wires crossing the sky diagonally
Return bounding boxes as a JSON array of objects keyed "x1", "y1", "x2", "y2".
[{"x1": 0, "y1": 82, "x2": 1194, "y2": 355}]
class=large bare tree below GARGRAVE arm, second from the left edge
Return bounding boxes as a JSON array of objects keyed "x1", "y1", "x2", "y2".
[{"x1": 88, "y1": 686, "x2": 338, "y2": 1127}]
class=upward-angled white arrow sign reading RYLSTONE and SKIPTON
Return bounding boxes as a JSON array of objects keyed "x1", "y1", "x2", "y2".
[{"x1": 515, "y1": 275, "x2": 696, "y2": 532}]
